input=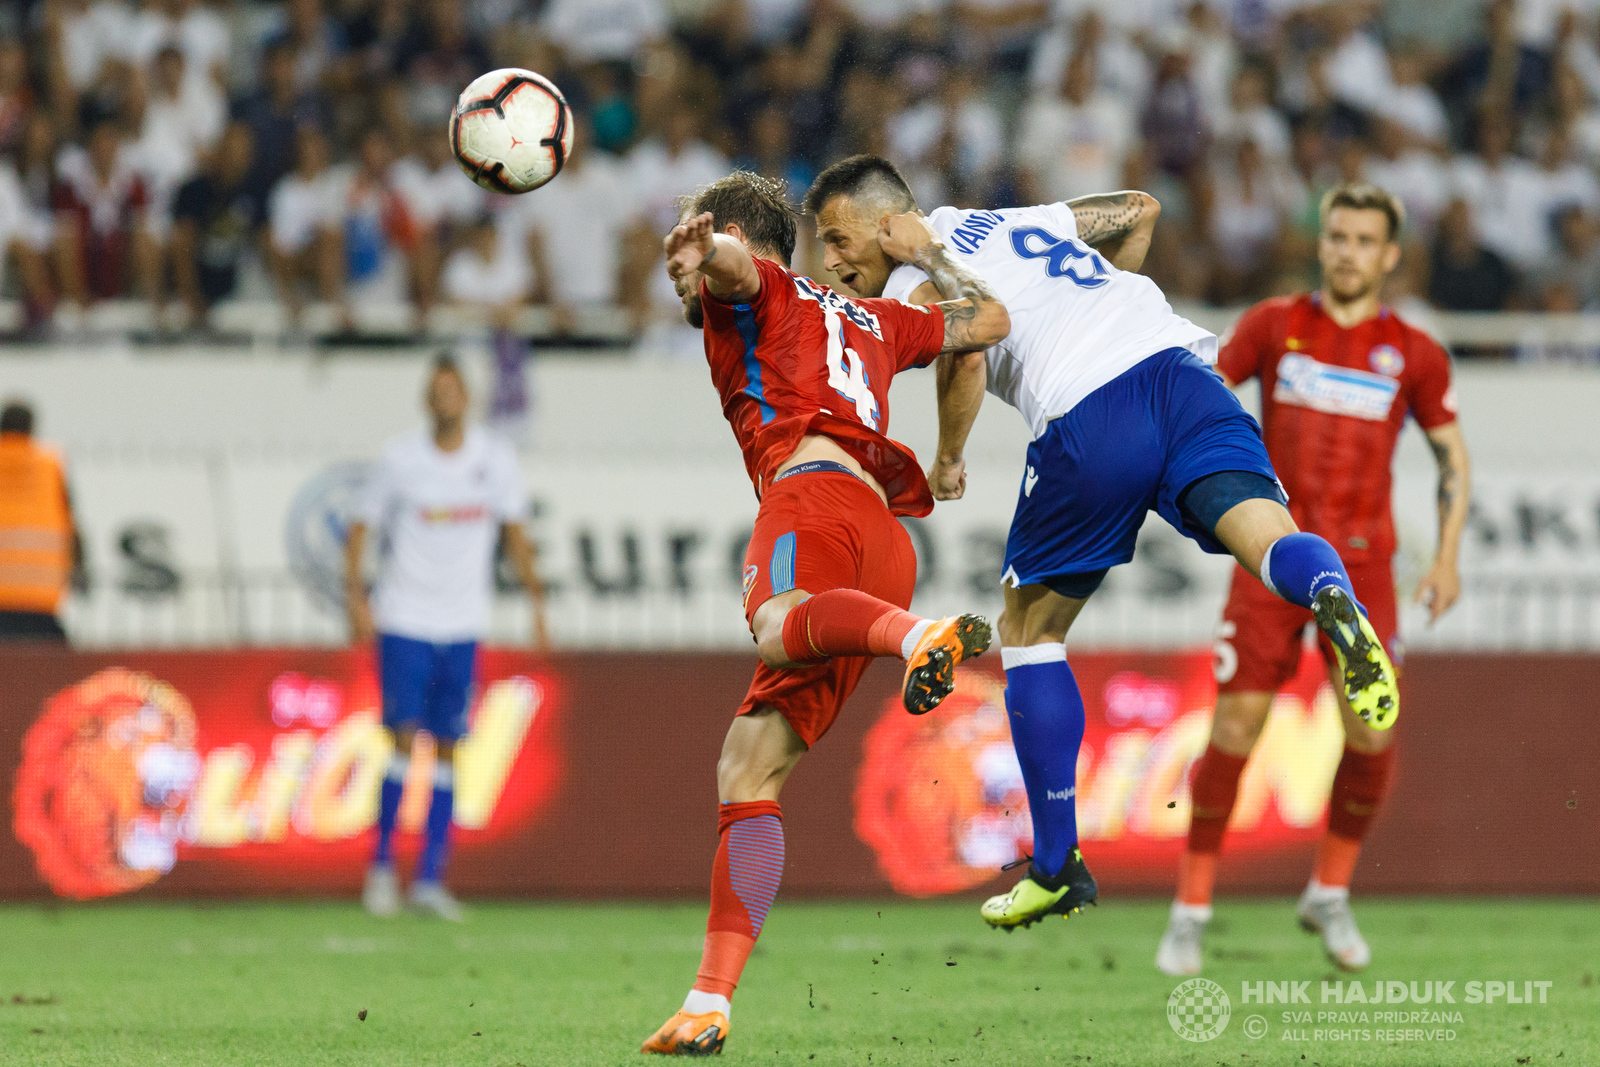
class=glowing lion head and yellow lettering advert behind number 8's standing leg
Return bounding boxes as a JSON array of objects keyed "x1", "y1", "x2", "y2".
[{"x1": 854, "y1": 653, "x2": 1344, "y2": 896}]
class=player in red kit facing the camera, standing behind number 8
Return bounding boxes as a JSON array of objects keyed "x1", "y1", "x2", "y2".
[{"x1": 1155, "y1": 182, "x2": 1470, "y2": 976}]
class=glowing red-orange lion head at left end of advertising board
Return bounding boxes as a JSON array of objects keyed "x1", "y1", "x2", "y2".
[{"x1": 13, "y1": 667, "x2": 200, "y2": 899}]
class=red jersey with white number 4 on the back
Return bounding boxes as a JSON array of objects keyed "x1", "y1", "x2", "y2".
[{"x1": 701, "y1": 258, "x2": 944, "y2": 515}]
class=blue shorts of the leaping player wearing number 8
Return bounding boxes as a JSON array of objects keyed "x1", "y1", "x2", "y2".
[{"x1": 1005, "y1": 349, "x2": 1277, "y2": 597}]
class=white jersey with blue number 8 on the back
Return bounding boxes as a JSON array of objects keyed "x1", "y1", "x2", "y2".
[{"x1": 883, "y1": 203, "x2": 1216, "y2": 437}]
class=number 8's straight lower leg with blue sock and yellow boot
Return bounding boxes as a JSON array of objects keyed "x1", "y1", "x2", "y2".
[{"x1": 981, "y1": 574, "x2": 1102, "y2": 931}]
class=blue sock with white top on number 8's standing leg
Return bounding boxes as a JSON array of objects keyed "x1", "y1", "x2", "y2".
[{"x1": 1000, "y1": 645, "x2": 1083, "y2": 875}]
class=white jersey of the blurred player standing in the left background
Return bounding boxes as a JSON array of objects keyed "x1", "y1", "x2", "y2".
[{"x1": 357, "y1": 427, "x2": 526, "y2": 645}]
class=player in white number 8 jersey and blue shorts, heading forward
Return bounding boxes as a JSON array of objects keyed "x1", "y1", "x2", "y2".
[{"x1": 805, "y1": 155, "x2": 1398, "y2": 929}]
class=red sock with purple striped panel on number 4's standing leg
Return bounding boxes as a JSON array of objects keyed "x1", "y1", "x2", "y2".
[{"x1": 694, "y1": 800, "x2": 784, "y2": 1000}]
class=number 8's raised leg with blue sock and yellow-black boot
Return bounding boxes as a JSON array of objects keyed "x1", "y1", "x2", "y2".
[{"x1": 1197, "y1": 489, "x2": 1400, "y2": 729}]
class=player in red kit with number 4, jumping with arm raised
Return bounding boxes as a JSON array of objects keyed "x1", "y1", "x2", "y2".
[{"x1": 643, "y1": 171, "x2": 1011, "y2": 1056}]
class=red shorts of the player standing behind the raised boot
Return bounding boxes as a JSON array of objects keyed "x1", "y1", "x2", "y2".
[{"x1": 1214, "y1": 560, "x2": 1405, "y2": 693}]
